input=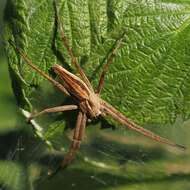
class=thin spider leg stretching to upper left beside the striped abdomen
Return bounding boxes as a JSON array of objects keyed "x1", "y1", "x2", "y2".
[{"x1": 9, "y1": 41, "x2": 70, "y2": 96}]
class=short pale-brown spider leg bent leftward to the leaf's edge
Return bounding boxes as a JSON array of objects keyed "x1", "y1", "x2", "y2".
[{"x1": 28, "y1": 105, "x2": 78, "y2": 122}]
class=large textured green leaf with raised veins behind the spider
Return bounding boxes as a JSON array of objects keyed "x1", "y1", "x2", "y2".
[{"x1": 6, "y1": 0, "x2": 190, "y2": 124}]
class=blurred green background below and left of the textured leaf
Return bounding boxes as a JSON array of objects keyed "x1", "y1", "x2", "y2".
[{"x1": 0, "y1": 0, "x2": 190, "y2": 190}]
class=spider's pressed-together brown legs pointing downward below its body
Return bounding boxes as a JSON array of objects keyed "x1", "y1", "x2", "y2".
[{"x1": 61, "y1": 111, "x2": 87, "y2": 168}]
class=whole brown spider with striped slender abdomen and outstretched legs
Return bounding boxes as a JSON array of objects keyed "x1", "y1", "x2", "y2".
[{"x1": 11, "y1": 4, "x2": 185, "y2": 171}]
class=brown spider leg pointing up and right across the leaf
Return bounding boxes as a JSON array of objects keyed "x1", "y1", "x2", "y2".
[{"x1": 96, "y1": 34, "x2": 124, "y2": 94}]
